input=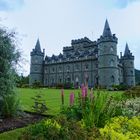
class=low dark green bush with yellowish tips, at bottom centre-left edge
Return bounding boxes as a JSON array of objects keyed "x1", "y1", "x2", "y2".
[{"x1": 20, "y1": 116, "x2": 86, "y2": 140}]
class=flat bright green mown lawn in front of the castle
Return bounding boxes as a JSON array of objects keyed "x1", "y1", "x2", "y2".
[{"x1": 17, "y1": 88, "x2": 79, "y2": 114}]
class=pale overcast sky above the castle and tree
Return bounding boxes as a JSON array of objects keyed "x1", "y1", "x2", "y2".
[{"x1": 0, "y1": 0, "x2": 140, "y2": 75}]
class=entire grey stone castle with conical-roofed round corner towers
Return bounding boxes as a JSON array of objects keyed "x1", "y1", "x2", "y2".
[{"x1": 29, "y1": 20, "x2": 135, "y2": 87}]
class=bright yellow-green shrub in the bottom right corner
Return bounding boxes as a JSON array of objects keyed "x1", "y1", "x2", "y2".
[{"x1": 100, "y1": 116, "x2": 140, "y2": 140}]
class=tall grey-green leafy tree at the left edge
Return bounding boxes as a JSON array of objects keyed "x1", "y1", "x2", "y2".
[{"x1": 0, "y1": 28, "x2": 20, "y2": 117}]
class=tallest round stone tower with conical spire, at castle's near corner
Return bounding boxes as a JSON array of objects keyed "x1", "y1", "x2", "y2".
[{"x1": 97, "y1": 20, "x2": 119, "y2": 87}]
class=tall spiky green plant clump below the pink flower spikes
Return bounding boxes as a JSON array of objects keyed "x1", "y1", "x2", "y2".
[{"x1": 61, "y1": 91, "x2": 122, "y2": 128}]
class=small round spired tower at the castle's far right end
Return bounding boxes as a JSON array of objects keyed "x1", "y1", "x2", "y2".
[{"x1": 122, "y1": 43, "x2": 135, "y2": 86}]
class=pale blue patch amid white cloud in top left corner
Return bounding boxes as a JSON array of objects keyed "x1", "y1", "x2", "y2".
[{"x1": 0, "y1": 0, "x2": 24, "y2": 11}]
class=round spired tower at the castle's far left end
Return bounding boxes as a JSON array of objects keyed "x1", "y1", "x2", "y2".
[{"x1": 29, "y1": 39, "x2": 44, "y2": 85}]
